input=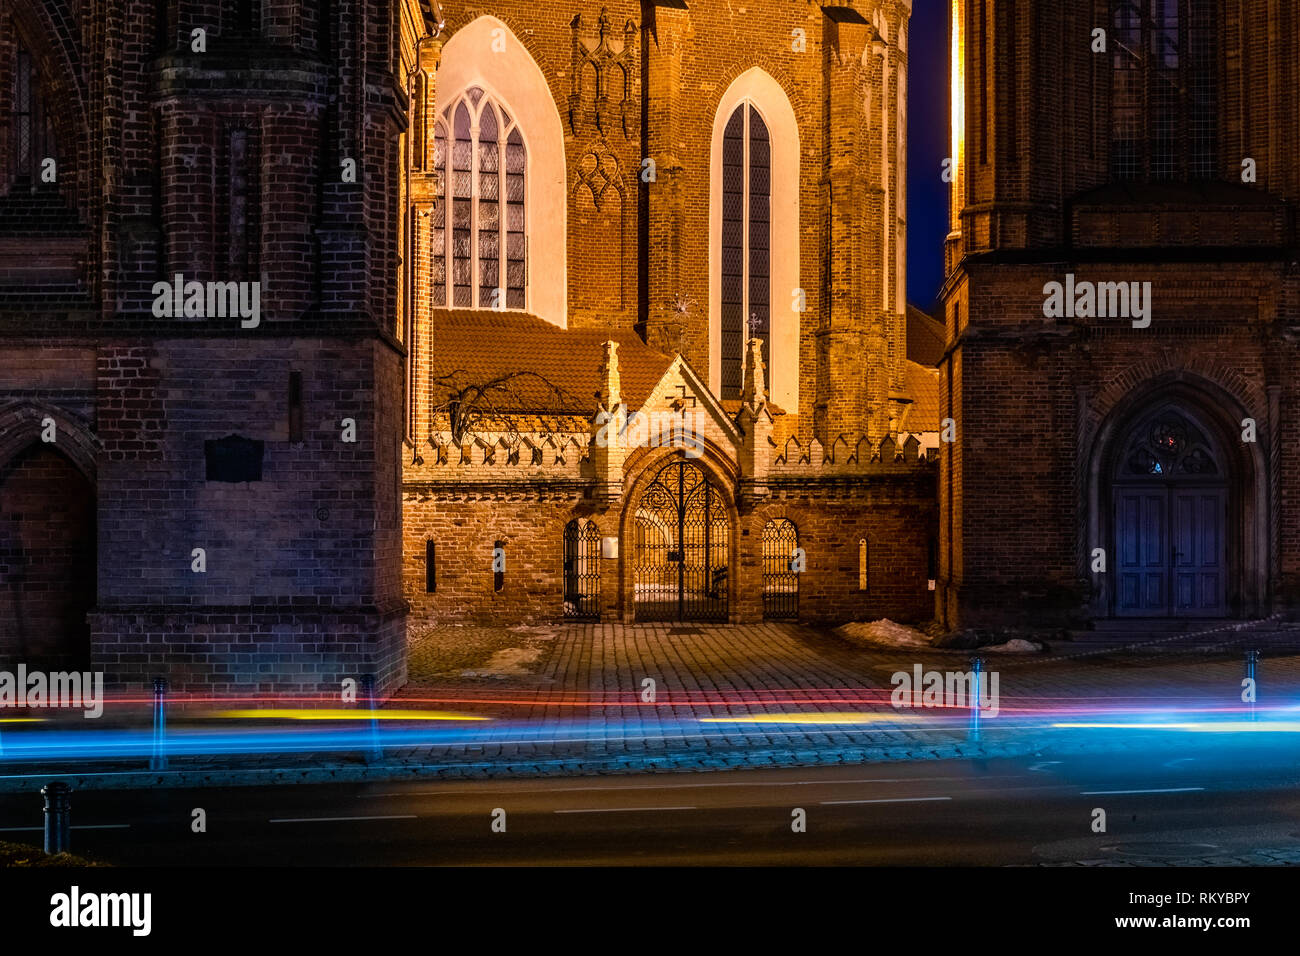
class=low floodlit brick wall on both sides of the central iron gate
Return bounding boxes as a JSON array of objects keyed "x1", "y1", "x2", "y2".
[{"x1": 404, "y1": 468, "x2": 937, "y2": 626}]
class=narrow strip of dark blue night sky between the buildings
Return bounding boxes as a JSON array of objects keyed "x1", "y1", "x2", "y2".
[{"x1": 907, "y1": 0, "x2": 948, "y2": 312}]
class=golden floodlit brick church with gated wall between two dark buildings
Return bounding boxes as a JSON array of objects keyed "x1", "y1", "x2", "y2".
[{"x1": 403, "y1": 0, "x2": 939, "y2": 628}]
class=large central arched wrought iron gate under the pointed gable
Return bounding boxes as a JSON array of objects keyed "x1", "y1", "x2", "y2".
[{"x1": 633, "y1": 460, "x2": 731, "y2": 620}]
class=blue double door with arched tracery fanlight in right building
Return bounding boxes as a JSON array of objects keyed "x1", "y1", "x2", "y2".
[{"x1": 1113, "y1": 405, "x2": 1231, "y2": 618}]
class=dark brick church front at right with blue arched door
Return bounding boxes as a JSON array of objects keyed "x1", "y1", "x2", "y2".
[{"x1": 937, "y1": 0, "x2": 1300, "y2": 627}]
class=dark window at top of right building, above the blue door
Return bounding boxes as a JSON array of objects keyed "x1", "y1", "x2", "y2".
[{"x1": 1110, "y1": 0, "x2": 1218, "y2": 181}]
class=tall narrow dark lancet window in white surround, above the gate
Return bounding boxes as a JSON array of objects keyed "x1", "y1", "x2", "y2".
[{"x1": 722, "y1": 103, "x2": 772, "y2": 398}]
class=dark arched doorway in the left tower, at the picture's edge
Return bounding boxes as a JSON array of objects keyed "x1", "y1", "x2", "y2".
[{"x1": 0, "y1": 442, "x2": 95, "y2": 670}]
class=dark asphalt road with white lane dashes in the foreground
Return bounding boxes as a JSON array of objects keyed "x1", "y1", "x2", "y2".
[{"x1": 0, "y1": 739, "x2": 1300, "y2": 866}]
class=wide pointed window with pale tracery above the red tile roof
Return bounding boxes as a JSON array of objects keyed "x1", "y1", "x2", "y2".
[{"x1": 432, "y1": 86, "x2": 528, "y2": 310}]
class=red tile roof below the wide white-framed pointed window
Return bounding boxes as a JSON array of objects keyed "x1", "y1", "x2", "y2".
[{"x1": 432, "y1": 310, "x2": 672, "y2": 416}]
